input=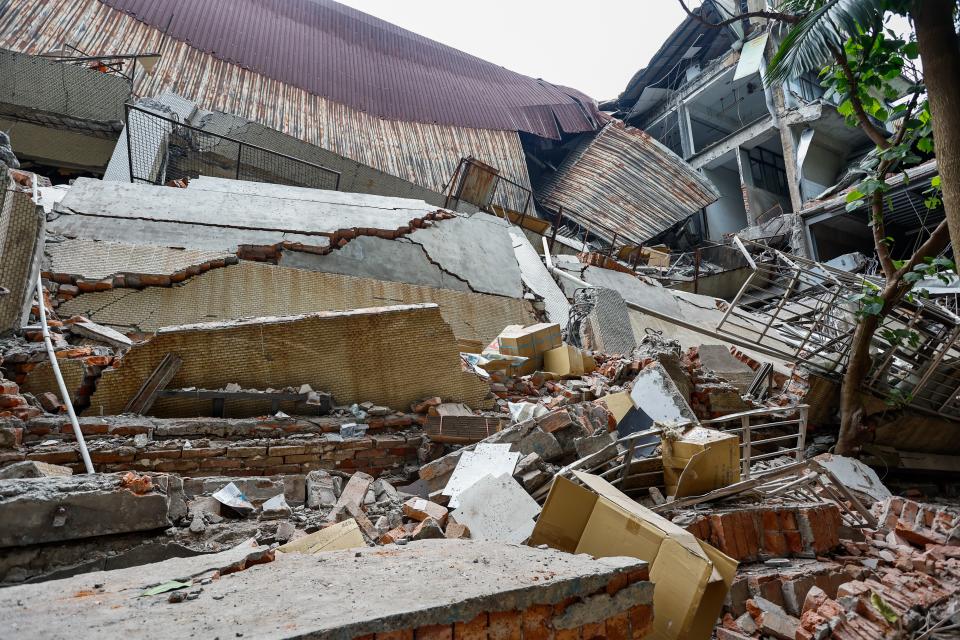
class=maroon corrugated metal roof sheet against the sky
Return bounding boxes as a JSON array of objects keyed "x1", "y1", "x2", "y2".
[{"x1": 90, "y1": 0, "x2": 601, "y2": 138}]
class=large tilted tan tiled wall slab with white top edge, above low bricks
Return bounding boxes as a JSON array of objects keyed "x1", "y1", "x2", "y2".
[{"x1": 88, "y1": 304, "x2": 489, "y2": 417}]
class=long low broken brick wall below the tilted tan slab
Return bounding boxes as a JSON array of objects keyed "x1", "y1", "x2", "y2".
[{"x1": 0, "y1": 415, "x2": 423, "y2": 477}]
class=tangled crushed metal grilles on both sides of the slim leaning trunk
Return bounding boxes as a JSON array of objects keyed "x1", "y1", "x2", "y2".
[{"x1": 717, "y1": 239, "x2": 960, "y2": 418}]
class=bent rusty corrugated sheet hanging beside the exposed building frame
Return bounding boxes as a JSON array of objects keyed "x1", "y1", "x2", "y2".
[{"x1": 539, "y1": 121, "x2": 720, "y2": 243}]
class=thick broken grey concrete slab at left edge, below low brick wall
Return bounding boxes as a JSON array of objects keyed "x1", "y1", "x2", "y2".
[{"x1": 0, "y1": 473, "x2": 179, "y2": 547}]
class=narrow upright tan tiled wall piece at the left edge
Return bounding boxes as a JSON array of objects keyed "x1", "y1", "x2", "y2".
[{"x1": 0, "y1": 168, "x2": 45, "y2": 334}]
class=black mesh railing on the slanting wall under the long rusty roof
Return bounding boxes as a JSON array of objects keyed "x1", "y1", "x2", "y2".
[{"x1": 126, "y1": 104, "x2": 340, "y2": 190}]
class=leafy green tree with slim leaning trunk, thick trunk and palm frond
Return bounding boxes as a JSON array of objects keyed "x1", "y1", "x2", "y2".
[{"x1": 680, "y1": 0, "x2": 960, "y2": 454}]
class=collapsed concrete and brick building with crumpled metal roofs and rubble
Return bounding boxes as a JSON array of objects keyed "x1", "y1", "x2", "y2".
[{"x1": 0, "y1": 0, "x2": 960, "y2": 640}]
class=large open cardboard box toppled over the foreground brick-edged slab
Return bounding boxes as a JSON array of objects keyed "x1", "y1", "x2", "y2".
[{"x1": 530, "y1": 471, "x2": 737, "y2": 640}]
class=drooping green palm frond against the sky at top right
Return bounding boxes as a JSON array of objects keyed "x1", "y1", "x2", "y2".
[{"x1": 766, "y1": 0, "x2": 884, "y2": 84}]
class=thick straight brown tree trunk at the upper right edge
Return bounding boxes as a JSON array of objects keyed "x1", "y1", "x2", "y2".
[{"x1": 910, "y1": 0, "x2": 960, "y2": 255}]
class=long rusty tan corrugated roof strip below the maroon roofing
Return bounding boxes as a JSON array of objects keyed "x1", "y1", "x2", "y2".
[{"x1": 0, "y1": 0, "x2": 530, "y2": 208}]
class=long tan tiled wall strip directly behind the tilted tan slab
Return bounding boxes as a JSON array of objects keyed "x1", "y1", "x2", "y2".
[{"x1": 57, "y1": 261, "x2": 536, "y2": 344}]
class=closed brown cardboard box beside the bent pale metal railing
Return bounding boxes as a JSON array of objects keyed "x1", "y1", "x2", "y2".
[{"x1": 662, "y1": 427, "x2": 740, "y2": 498}]
